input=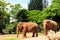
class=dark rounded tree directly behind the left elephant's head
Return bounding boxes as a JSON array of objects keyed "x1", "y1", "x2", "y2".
[{"x1": 17, "y1": 9, "x2": 28, "y2": 22}]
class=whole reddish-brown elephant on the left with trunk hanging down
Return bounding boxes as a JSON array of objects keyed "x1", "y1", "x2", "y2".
[{"x1": 16, "y1": 22, "x2": 39, "y2": 37}]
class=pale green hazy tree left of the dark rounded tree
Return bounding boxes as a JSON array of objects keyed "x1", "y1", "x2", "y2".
[{"x1": 10, "y1": 4, "x2": 21, "y2": 19}]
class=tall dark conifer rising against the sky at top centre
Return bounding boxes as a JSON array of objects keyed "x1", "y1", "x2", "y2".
[{"x1": 28, "y1": 0, "x2": 43, "y2": 10}]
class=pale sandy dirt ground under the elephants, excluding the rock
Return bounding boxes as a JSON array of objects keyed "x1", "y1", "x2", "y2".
[{"x1": 0, "y1": 33, "x2": 48, "y2": 40}]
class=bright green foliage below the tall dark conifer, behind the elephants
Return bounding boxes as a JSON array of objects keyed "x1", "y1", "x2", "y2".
[{"x1": 27, "y1": 10, "x2": 48, "y2": 23}]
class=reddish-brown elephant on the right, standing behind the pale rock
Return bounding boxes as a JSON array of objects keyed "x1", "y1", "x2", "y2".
[{"x1": 43, "y1": 20, "x2": 58, "y2": 35}]
